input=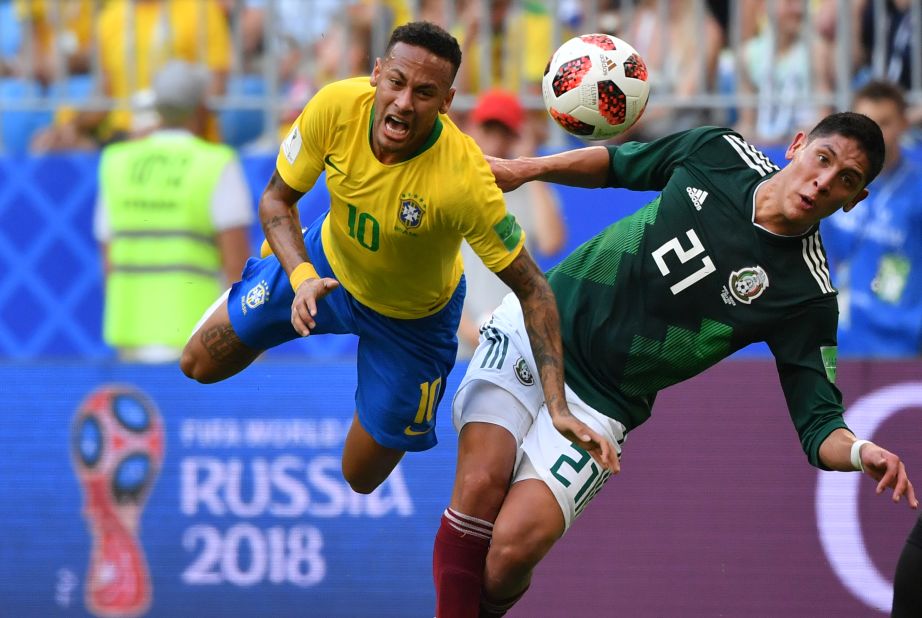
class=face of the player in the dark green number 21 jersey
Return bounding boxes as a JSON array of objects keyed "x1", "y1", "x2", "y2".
[{"x1": 781, "y1": 132, "x2": 870, "y2": 234}]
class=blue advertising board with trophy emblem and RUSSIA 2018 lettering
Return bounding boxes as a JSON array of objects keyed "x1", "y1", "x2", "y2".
[{"x1": 0, "y1": 362, "x2": 462, "y2": 618}]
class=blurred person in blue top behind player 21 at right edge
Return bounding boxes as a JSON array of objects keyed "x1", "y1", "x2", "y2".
[{"x1": 822, "y1": 81, "x2": 922, "y2": 357}]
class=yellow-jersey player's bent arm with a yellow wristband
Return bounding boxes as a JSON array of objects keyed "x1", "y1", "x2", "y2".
[{"x1": 259, "y1": 170, "x2": 339, "y2": 337}]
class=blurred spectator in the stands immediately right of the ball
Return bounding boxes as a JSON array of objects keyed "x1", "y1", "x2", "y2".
[{"x1": 624, "y1": 0, "x2": 723, "y2": 141}]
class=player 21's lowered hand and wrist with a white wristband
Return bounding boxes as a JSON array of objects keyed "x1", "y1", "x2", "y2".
[{"x1": 820, "y1": 429, "x2": 919, "y2": 509}]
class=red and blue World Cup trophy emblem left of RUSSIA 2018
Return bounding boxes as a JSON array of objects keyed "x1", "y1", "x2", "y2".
[{"x1": 71, "y1": 385, "x2": 164, "y2": 617}]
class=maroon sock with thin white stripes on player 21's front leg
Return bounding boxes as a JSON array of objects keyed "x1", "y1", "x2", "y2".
[{"x1": 432, "y1": 509, "x2": 493, "y2": 618}]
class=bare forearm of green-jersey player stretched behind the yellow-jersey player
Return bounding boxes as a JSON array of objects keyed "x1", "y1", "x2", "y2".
[{"x1": 486, "y1": 146, "x2": 609, "y2": 191}]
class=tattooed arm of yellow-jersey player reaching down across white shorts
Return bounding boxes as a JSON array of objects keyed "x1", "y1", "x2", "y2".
[{"x1": 497, "y1": 248, "x2": 620, "y2": 473}]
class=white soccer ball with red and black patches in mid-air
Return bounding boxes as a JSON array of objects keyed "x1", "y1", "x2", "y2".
[{"x1": 541, "y1": 34, "x2": 650, "y2": 140}]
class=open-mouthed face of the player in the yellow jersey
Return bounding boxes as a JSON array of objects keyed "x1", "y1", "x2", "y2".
[{"x1": 371, "y1": 43, "x2": 455, "y2": 163}]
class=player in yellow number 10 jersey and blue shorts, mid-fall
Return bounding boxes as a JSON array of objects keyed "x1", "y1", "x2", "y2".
[{"x1": 181, "y1": 22, "x2": 617, "y2": 500}]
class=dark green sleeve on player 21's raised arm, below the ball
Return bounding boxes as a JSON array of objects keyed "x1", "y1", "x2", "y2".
[{"x1": 606, "y1": 127, "x2": 730, "y2": 191}]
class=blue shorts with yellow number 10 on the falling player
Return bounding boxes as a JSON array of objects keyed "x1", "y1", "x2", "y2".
[{"x1": 227, "y1": 215, "x2": 465, "y2": 451}]
